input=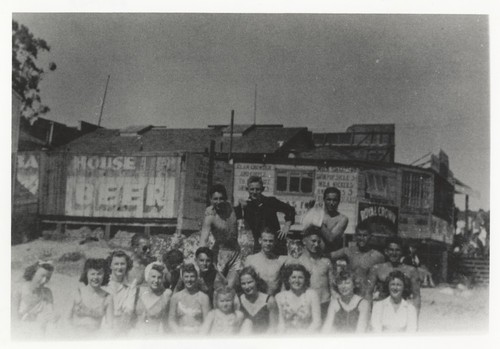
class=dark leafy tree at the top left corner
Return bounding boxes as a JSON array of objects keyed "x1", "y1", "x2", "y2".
[{"x1": 12, "y1": 21, "x2": 56, "y2": 119}]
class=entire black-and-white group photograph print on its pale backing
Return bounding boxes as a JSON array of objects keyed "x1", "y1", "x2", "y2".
[{"x1": 4, "y1": 0, "x2": 494, "y2": 345}]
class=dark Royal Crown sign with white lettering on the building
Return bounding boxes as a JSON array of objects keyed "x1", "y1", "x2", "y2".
[{"x1": 358, "y1": 202, "x2": 398, "y2": 236}]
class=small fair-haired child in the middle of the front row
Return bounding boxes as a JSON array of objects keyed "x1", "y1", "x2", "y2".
[{"x1": 200, "y1": 286, "x2": 251, "y2": 335}]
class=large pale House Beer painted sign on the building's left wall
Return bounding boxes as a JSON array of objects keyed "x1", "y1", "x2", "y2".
[{"x1": 65, "y1": 155, "x2": 180, "y2": 218}]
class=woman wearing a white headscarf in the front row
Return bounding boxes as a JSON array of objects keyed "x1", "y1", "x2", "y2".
[{"x1": 135, "y1": 262, "x2": 172, "y2": 334}]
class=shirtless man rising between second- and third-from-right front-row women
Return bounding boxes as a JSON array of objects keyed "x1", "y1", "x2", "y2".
[{"x1": 286, "y1": 226, "x2": 335, "y2": 320}]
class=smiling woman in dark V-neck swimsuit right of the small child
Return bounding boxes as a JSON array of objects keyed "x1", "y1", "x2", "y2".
[{"x1": 239, "y1": 267, "x2": 278, "y2": 334}]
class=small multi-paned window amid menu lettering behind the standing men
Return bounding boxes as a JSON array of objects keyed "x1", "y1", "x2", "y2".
[{"x1": 276, "y1": 170, "x2": 314, "y2": 195}]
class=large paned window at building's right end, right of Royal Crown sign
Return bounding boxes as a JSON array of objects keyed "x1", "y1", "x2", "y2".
[{"x1": 401, "y1": 172, "x2": 431, "y2": 208}]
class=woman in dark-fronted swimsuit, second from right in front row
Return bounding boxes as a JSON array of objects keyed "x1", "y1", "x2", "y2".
[{"x1": 322, "y1": 271, "x2": 370, "y2": 333}]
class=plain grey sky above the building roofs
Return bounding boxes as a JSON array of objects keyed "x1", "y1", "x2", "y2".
[{"x1": 12, "y1": 13, "x2": 490, "y2": 209}]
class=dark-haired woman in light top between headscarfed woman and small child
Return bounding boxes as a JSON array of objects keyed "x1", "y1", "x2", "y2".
[{"x1": 168, "y1": 264, "x2": 210, "y2": 335}]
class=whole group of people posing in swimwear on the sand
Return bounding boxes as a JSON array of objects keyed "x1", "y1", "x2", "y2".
[{"x1": 12, "y1": 177, "x2": 420, "y2": 336}]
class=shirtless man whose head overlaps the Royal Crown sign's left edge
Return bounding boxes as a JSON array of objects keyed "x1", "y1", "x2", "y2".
[{"x1": 330, "y1": 223, "x2": 385, "y2": 297}]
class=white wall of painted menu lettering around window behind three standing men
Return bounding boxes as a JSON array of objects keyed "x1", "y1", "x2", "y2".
[{"x1": 234, "y1": 163, "x2": 358, "y2": 234}]
